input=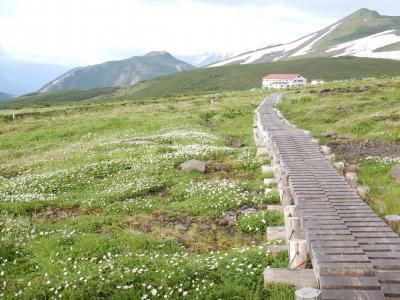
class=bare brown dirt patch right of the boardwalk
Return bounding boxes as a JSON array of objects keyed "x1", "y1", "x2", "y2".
[{"x1": 329, "y1": 140, "x2": 400, "y2": 161}]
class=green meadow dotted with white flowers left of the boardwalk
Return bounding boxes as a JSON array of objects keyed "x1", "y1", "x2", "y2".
[{"x1": 0, "y1": 91, "x2": 294, "y2": 299}]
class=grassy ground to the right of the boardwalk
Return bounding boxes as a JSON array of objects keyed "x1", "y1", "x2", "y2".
[{"x1": 280, "y1": 78, "x2": 400, "y2": 215}]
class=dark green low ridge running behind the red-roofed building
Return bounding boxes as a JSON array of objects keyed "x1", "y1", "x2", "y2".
[{"x1": 0, "y1": 57, "x2": 400, "y2": 109}]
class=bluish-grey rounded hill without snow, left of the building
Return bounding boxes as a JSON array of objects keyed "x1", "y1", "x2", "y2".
[{"x1": 39, "y1": 51, "x2": 194, "y2": 92}]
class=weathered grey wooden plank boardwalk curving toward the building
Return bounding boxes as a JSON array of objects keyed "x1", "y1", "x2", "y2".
[{"x1": 257, "y1": 94, "x2": 400, "y2": 300}]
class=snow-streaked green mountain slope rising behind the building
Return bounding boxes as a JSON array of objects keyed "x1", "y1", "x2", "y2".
[{"x1": 210, "y1": 8, "x2": 400, "y2": 67}]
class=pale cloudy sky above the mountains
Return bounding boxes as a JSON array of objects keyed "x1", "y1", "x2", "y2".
[{"x1": 0, "y1": 0, "x2": 400, "y2": 66}]
